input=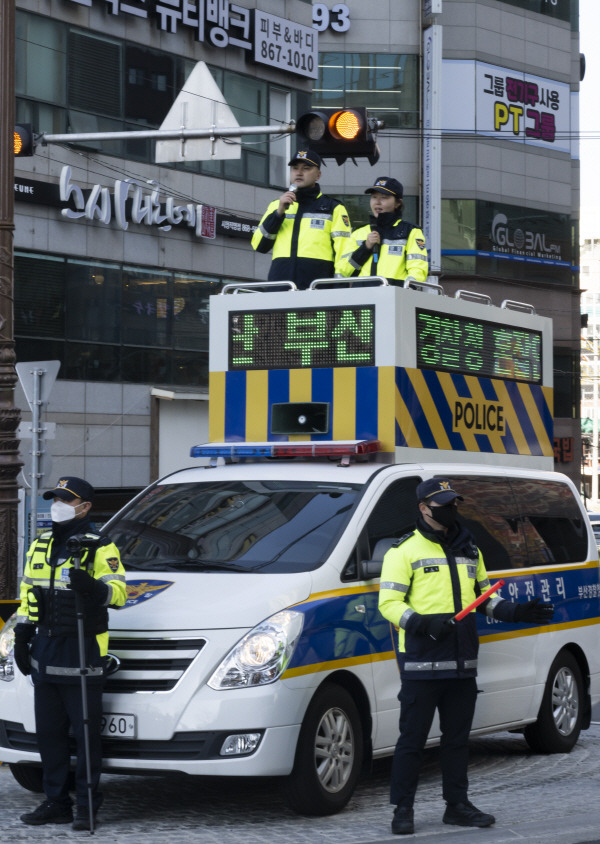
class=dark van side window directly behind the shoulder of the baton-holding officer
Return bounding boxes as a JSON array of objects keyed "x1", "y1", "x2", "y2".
[{"x1": 450, "y1": 476, "x2": 531, "y2": 572}]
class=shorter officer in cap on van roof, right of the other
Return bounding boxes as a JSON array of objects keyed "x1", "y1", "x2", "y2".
[{"x1": 342, "y1": 176, "x2": 429, "y2": 284}]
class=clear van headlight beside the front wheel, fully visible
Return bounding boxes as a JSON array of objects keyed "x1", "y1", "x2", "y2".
[{"x1": 208, "y1": 610, "x2": 304, "y2": 690}]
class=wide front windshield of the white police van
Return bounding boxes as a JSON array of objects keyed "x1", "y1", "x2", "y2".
[{"x1": 108, "y1": 481, "x2": 362, "y2": 572}]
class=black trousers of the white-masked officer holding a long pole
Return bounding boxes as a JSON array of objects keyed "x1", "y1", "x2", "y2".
[{"x1": 34, "y1": 683, "x2": 102, "y2": 811}]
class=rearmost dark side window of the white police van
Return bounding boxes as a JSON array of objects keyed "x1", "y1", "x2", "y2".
[{"x1": 511, "y1": 479, "x2": 588, "y2": 566}]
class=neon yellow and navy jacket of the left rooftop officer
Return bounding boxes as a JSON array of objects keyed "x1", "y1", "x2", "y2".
[{"x1": 252, "y1": 191, "x2": 351, "y2": 290}]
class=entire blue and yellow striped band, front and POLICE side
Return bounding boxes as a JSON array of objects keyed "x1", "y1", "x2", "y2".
[{"x1": 209, "y1": 366, "x2": 554, "y2": 457}]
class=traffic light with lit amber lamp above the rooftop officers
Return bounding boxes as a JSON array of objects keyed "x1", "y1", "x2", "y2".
[{"x1": 296, "y1": 108, "x2": 383, "y2": 164}]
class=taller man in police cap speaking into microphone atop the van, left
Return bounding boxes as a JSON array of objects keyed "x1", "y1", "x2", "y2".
[{"x1": 252, "y1": 149, "x2": 351, "y2": 290}]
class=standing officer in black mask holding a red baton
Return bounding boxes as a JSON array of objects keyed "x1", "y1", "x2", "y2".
[{"x1": 379, "y1": 478, "x2": 554, "y2": 835}]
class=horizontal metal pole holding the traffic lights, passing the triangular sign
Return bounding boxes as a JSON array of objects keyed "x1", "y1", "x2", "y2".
[{"x1": 41, "y1": 121, "x2": 296, "y2": 145}]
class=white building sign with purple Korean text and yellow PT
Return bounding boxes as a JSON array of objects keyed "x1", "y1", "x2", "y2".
[{"x1": 442, "y1": 60, "x2": 571, "y2": 153}]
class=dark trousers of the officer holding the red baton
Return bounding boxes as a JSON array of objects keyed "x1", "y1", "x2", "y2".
[{"x1": 390, "y1": 678, "x2": 477, "y2": 806}]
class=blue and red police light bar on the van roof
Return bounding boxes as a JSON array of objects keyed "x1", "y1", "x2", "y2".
[{"x1": 190, "y1": 440, "x2": 380, "y2": 459}]
